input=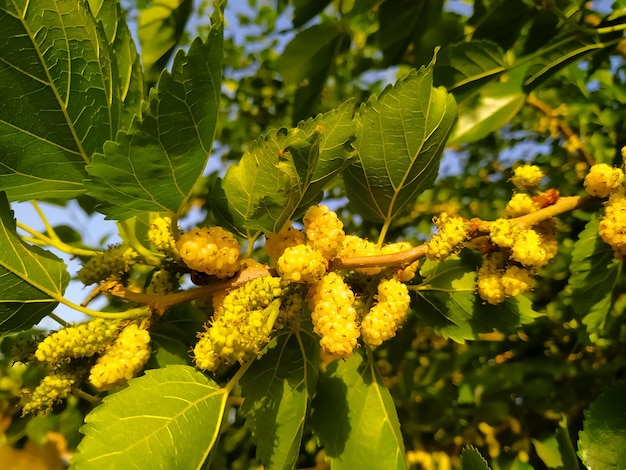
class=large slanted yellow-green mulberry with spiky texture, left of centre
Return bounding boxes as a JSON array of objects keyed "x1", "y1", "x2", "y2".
[{"x1": 194, "y1": 276, "x2": 288, "y2": 371}]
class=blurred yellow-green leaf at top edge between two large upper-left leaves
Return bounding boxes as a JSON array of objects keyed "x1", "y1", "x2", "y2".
[{"x1": 137, "y1": 0, "x2": 193, "y2": 82}]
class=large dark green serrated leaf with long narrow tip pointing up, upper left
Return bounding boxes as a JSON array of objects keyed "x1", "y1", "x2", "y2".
[{"x1": 85, "y1": 4, "x2": 223, "y2": 219}]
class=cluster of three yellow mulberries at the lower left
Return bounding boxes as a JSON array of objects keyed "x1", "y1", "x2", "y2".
[{"x1": 16, "y1": 319, "x2": 150, "y2": 414}]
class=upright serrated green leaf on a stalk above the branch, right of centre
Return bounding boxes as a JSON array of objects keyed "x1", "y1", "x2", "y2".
[{"x1": 344, "y1": 59, "x2": 456, "y2": 223}]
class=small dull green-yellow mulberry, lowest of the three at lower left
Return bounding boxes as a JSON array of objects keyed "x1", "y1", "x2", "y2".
[{"x1": 22, "y1": 369, "x2": 79, "y2": 416}]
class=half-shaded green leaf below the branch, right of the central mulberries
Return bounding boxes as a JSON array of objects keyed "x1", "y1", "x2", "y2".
[{"x1": 412, "y1": 251, "x2": 538, "y2": 342}]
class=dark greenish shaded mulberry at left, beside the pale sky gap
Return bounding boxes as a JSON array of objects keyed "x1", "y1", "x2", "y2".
[{"x1": 77, "y1": 245, "x2": 139, "y2": 285}]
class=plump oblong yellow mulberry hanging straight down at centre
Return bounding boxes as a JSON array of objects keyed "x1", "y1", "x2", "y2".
[{"x1": 309, "y1": 272, "x2": 360, "y2": 359}]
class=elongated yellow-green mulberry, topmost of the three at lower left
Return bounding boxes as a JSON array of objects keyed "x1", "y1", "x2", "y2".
[{"x1": 35, "y1": 318, "x2": 120, "y2": 365}]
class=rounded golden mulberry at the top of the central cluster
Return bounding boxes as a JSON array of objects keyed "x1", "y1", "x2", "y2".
[{"x1": 302, "y1": 206, "x2": 346, "y2": 259}]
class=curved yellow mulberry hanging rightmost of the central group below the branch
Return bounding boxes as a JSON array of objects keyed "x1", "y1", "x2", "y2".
[{"x1": 361, "y1": 279, "x2": 411, "y2": 346}]
